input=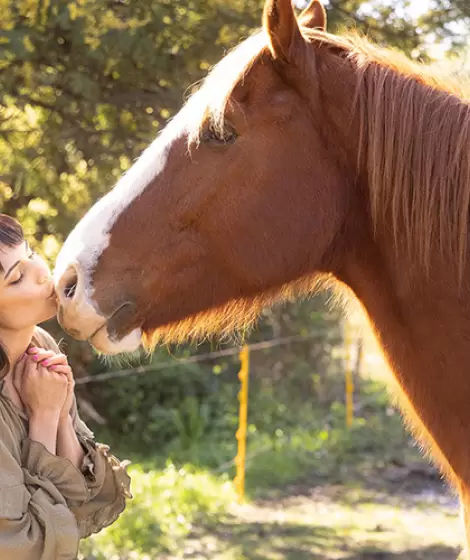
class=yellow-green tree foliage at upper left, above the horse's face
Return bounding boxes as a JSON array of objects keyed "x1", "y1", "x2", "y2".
[{"x1": 0, "y1": 0, "x2": 261, "y2": 258}]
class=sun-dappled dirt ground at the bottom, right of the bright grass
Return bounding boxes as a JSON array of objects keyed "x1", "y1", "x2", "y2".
[{"x1": 179, "y1": 467, "x2": 463, "y2": 560}]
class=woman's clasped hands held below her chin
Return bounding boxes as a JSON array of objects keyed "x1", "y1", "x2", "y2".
[{"x1": 13, "y1": 354, "x2": 68, "y2": 419}]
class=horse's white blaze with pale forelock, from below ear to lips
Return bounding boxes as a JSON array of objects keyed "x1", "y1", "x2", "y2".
[{"x1": 54, "y1": 33, "x2": 267, "y2": 353}]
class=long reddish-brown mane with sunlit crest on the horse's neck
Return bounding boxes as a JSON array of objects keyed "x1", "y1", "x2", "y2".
[{"x1": 327, "y1": 30, "x2": 470, "y2": 280}]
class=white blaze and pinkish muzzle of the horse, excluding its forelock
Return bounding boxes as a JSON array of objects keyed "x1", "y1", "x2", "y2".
[{"x1": 54, "y1": 104, "x2": 186, "y2": 354}]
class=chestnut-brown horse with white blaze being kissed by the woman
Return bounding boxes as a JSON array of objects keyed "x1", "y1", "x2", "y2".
[{"x1": 56, "y1": 0, "x2": 470, "y2": 552}]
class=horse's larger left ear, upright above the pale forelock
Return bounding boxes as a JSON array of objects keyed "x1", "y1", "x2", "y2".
[{"x1": 263, "y1": 0, "x2": 304, "y2": 62}]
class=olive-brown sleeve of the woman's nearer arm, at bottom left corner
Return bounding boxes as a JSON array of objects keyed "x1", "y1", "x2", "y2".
[{"x1": 0, "y1": 426, "x2": 79, "y2": 560}]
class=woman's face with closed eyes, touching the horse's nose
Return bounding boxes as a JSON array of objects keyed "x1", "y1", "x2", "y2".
[{"x1": 0, "y1": 242, "x2": 57, "y2": 330}]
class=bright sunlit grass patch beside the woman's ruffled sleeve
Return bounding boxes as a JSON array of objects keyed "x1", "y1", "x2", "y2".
[{"x1": 79, "y1": 463, "x2": 235, "y2": 560}]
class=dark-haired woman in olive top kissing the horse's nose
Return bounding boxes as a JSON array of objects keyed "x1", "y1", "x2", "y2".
[{"x1": 0, "y1": 214, "x2": 131, "y2": 560}]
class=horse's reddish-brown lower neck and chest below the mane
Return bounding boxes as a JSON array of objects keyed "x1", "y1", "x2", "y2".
[{"x1": 339, "y1": 243, "x2": 470, "y2": 482}]
